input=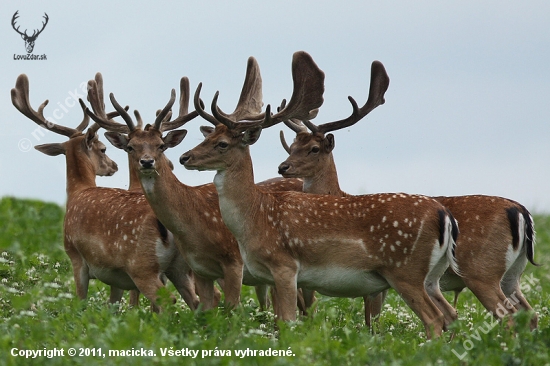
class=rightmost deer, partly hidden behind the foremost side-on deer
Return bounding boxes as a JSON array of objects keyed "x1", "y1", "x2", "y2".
[{"x1": 279, "y1": 61, "x2": 537, "y2": 328}]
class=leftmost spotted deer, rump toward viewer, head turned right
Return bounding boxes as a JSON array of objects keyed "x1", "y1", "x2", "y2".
[{"x1": 11, "y1": 74, "x2": 198, "y2": 309}]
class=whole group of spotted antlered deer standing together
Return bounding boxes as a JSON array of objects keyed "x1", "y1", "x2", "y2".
[{"x1": 11, "y1": 52, "x2": 537, "y2": 338}]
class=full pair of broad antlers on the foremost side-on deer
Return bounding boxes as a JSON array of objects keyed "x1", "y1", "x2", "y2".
[{"x1": 199, "y1": 51, "x2": 325, "y2": 129}]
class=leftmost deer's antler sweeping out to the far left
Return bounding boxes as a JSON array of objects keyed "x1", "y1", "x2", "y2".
[{"x1": 11, "y1": 74, "x2": 78, "y2": 137}]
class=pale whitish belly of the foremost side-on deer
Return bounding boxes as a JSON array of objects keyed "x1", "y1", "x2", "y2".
[{"x1": 298, "y1": 267, "x2": 390, "y2": 297}]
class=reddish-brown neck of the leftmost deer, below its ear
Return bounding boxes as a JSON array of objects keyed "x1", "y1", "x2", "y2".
[{"x1": 65, "y1": 139, "x2": 96, "y2": 197}]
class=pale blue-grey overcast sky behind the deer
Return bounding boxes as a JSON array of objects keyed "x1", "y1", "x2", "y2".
[{"x1": 0, "y1": 0, "x2": 550, "y2": 213}]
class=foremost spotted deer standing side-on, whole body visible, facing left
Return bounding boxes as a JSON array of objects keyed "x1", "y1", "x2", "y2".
[{"x1": 180, "y1": 52, "x2": 458, "y2": 338}]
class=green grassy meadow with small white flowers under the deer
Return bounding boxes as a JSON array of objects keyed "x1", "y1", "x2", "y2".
[{"x1": 0, "y1": 198, "x2": 550, "y2": 365}]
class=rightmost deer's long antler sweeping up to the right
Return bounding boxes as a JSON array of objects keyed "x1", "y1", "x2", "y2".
[{"x1": 303, "y1": 61, "x2": 390, "y2": 133}]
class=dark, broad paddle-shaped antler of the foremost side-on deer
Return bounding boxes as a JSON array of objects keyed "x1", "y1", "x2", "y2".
[{"x1": 262, "y1": 51, "x2": 325, "y2": 128}]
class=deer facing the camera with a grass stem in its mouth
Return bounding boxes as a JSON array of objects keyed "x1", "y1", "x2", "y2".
[{"x1": 87, "y1": 59, "x2": 308, "y2": 309}]
